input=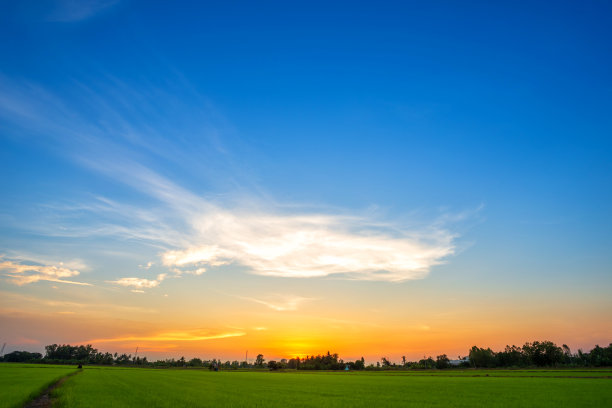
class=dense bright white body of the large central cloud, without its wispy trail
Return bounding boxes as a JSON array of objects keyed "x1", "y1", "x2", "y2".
[{"x1": 162, "y1": 206, "x2": 455, "y2": 281}]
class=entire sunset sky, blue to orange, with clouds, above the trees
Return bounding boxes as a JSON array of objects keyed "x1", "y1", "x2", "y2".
[{"x1": 0, "y1": 0, "x2": 612, "y2": 362}]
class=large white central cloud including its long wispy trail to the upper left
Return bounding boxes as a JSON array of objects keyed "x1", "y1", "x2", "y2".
[{"x1": 0, "y1": 78, "x2": 464, "y2": 289}]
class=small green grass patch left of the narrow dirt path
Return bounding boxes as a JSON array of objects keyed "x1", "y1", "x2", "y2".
[{"x1": 0, "y1": 363, "x2": 77, "y2": 408}]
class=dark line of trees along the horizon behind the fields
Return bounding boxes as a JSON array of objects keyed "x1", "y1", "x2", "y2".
[{"x1": 0, "y1": 341, "x2": 612, "y2": 370}]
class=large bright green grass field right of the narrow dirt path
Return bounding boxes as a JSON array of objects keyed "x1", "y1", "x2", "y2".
[{"x1": 54, "y1": 367, "x2": 612, "y2": 408}]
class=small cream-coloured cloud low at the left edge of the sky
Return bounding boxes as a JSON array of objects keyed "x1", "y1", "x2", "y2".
[{"x1": 0, "y1": 256, "x2": 91, "y2": 286}]
